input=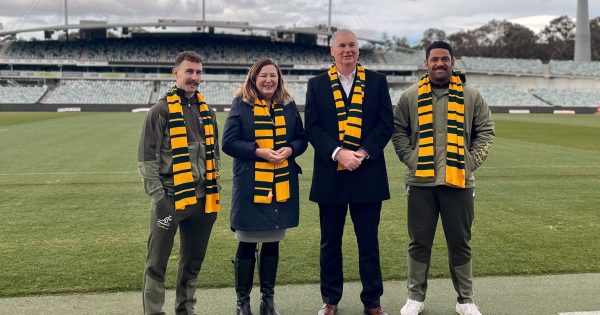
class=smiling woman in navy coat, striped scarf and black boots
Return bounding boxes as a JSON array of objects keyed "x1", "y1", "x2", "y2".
[{"x1": 222, "y1": 58, "x2": 308, "y2": 314}]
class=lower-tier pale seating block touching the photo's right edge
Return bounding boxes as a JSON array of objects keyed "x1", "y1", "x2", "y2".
[{"x1": 530, "y1": 88, "x2": 600, "y2": 107}]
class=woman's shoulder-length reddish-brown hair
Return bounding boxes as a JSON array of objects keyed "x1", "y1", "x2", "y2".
[{"x1": 235, "y1": 58, "x2": 292, "y2": 104}]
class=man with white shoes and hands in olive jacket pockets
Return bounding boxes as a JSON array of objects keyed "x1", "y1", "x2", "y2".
[{"x1": 392, "y1": 41, "x2": 494, "y2": 315}]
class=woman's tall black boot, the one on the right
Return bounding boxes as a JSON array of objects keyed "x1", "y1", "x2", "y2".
[{"x1": 258, "y1": 256, "x2": 280, "y2": 315}]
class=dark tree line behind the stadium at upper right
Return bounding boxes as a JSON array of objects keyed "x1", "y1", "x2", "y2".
[{"x1": 371, "y1": 15, "x2": 600, "y2": 62}]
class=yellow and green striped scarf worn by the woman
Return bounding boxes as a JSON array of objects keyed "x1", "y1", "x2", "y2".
[{"x1": 254, "y1": 98, "x2": 290, "y2": 204}]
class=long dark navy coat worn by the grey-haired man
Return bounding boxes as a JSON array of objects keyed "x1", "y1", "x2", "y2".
[{"x1": 305, "y1": 70, "x2": 394, "y2": 204}]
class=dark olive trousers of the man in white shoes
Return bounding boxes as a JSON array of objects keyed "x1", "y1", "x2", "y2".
[{"x1": 407, "y1": 186, "x2": 475, "y2": 303}]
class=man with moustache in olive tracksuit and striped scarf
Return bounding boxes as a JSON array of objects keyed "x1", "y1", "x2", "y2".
[{"x1": 138, "y1": 51, "x2": 219, "y2": 315}]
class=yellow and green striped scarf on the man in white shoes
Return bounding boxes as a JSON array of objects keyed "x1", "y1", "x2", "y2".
[{"x1": 415, "y1": 73, "x2": 465, "y2": 188}]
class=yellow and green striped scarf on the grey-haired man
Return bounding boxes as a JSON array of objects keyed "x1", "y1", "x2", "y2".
[{"x1": 328, "y1": 64, "x2": 365, "y2": 171}]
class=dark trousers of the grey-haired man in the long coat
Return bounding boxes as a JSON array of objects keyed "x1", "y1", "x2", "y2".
[{"x1": 319, "y1": 202, "x2": 383, "y2": 308}]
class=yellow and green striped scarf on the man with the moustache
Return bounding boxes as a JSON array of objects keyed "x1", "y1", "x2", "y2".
[{"x1": 167, "y1": 86, "x2": 221, "y2": 213}]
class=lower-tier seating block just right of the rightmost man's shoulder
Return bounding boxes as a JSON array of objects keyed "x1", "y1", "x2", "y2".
[{"x1": 471, "y1": 84, "x2": 549, "y2": 107}]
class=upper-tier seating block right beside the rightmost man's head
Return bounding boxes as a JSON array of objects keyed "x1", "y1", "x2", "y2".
[{"x1": 461, "y1": 56, "x2": 544, "y2": 75}]
